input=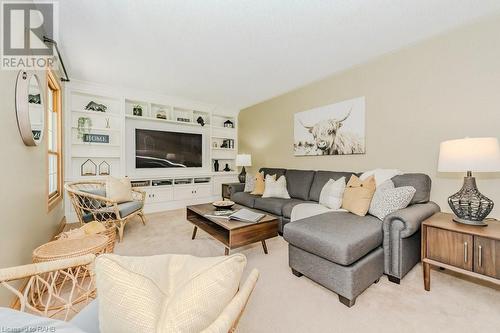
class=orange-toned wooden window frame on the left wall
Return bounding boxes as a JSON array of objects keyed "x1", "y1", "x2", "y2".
[{"x1": 46, "y1": 70, "x2": 63, "y2": 211}]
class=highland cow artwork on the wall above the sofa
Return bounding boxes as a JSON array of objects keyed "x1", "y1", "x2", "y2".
[{"x1": 293, "y1": 97, "x2": 365, "y2": 156}]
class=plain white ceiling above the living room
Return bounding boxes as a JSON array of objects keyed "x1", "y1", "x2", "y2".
[{"x1": 59, "y1": 0, "x2": 500, "y2": 109}]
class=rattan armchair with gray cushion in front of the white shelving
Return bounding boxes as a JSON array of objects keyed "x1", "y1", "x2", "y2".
[{"x1": 64, "y1": 181, "x2": 146, "y2": 242}]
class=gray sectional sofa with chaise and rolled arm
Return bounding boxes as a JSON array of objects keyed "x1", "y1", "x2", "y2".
[{"x1": 230, "y1": 168, "x2": 439, "y2": 306}]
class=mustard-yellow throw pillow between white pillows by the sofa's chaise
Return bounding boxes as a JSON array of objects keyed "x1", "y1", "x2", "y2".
[{"x1": 342, "y1": 175, "x2": 376, "y2": 216}]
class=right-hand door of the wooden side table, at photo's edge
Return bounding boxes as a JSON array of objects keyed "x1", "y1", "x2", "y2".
[{"x1": 474, "y1": 236, "x2": 500, "y2": 279}]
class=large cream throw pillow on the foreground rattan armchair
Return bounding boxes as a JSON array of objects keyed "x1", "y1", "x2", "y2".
[{"x1": 96, "y1": 254, "x2": 246, "y2": 333}]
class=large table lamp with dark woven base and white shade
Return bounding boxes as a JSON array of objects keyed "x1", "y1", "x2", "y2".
[{"x1": 438, "y1": 138, "x2": 500, "y2": 226}]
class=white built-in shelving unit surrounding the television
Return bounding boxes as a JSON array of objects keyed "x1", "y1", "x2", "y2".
[{"x1": 64, "y1": 82, "x2": 238, "y2": 220}]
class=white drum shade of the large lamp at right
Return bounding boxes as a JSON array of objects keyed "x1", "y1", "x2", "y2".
[{"x1": 438, "y1": 138, "x2": 500, "y2": 172}]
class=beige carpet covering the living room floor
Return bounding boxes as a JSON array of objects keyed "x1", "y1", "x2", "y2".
[{"x1": 115, "y1": 210, "x2": 500, "y2": 333}]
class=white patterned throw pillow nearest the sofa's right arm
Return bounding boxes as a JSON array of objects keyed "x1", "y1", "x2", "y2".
[{"x1": 369, "y1": 180, "x2": 416, "y2": 220}]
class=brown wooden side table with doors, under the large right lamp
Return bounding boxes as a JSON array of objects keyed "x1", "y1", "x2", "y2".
[{"x1": 422, "y1": 213, "x2": 500, "y2": 291}]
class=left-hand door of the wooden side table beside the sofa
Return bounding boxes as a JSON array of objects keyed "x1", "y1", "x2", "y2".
[{"x1": 426, "y1": 227, "x2": 474, "y2": 271}]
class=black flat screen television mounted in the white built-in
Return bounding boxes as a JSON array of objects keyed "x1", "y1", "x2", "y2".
[{"x1": 135, "y1": 128, "x2": 203, "y2": 169}]
